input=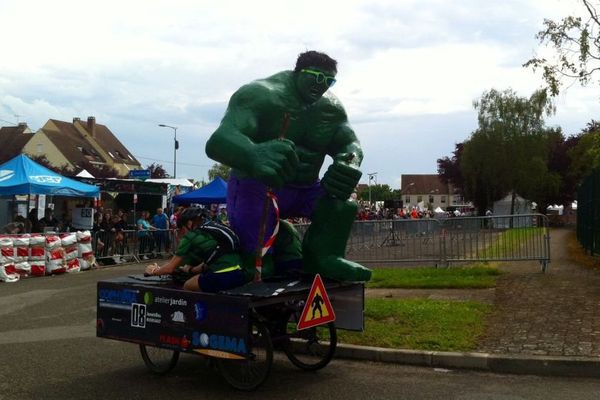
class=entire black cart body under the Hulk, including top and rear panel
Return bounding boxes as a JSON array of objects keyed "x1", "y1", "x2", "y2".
[{"x1": 97, "y1": 275, "x2": 364, "y2": 359}]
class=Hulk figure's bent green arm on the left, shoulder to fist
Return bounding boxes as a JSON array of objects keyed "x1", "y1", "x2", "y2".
[{"x1": 206, "y1": 83, "x2": 298, "y2": 187}]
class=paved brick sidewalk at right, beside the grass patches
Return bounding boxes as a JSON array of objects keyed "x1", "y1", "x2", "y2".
[{"x1": 478, "y1": 229, "x2": 600, "y2": 357}]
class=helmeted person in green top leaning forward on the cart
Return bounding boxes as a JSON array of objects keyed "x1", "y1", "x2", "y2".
[{"x1": 145, "y1": 207, "x2": 254, "y2": 293}]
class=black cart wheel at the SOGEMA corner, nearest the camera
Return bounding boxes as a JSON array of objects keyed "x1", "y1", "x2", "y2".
[{"x1": 215, "y1": 321, "x2": 273, "y2": 391}]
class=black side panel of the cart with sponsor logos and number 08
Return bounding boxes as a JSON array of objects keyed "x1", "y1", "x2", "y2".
[{"x1": 97, "y1": 277, "x2": 250, "y2": 358}]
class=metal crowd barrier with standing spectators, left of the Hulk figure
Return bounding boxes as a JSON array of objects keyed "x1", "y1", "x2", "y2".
[{"x1": 92, "y1": 229, "x2": 179, "y2": 265}]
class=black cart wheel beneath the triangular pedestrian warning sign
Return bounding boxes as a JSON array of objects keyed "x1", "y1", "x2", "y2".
[{"x1": 283, "y1": 314, "x2": 337, "y2": 371}]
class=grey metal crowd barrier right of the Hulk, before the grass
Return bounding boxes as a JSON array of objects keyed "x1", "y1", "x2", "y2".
[{"x1": 296, "y1": 214, "x2": 550, "y2": 271}]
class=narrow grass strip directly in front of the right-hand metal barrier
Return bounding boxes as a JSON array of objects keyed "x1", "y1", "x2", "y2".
[{"x1": 367, "y1": 263, "x2": 502, "y2": 289}]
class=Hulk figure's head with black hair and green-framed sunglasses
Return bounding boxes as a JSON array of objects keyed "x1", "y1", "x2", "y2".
[{"x1": 294, "y1": 50, "x2": 337, "y2": 104}]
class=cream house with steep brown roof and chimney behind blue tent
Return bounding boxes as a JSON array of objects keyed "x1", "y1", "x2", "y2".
[{"x1": 23, "y1": 117, "x2": 142, "y2": 175}]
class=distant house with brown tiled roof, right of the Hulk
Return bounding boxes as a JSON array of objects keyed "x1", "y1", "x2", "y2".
[{"x1": 401, "y1": 174, "x2": 464, "y2": 210}]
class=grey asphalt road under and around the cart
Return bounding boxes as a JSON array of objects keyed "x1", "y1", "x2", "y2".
[{"x1": 0, "y1": 265, "x2": 600, "y2": 400}]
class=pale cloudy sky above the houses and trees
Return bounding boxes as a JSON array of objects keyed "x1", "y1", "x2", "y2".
[{"x1": 0, "y1": 0, "x2": 600, "y2": 189}]
